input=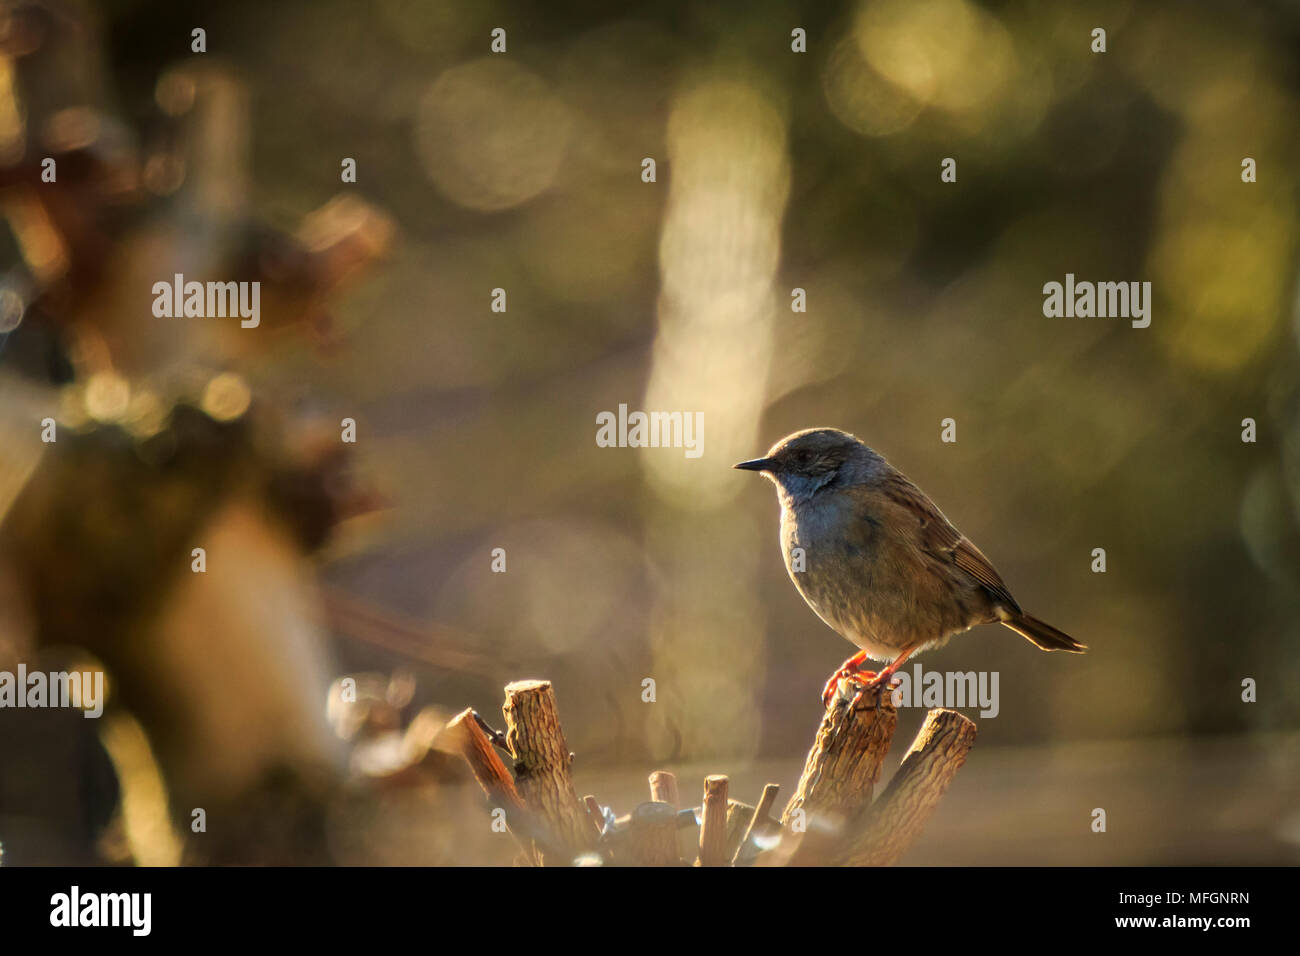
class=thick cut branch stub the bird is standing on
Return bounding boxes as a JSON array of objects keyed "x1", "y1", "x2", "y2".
[{"x1": 781, "y1": 692, "x2": 898, "y2": 832}]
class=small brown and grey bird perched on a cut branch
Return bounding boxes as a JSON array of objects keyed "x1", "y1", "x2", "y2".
[{"x1": 735, "y1": 428, "x2": 1087, "y2": 705}]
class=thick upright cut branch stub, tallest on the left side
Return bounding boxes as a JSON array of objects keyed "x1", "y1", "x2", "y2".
[{"x1": 502, "y1": 680, "x2": 595, "y2": 865}]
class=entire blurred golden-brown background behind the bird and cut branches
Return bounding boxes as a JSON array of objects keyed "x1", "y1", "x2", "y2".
[{"x1": 0, "y1": 0, "x2": 1300, "y2": 865}]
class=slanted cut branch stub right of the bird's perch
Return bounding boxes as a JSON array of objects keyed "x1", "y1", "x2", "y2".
[{"x1": 831, "y1": 710, "x2": 975, "y2": 866}]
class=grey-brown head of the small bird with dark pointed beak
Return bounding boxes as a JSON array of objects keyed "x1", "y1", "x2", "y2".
[{"x1": 735, "y1": 428, "x2": 884, "y2": 502}]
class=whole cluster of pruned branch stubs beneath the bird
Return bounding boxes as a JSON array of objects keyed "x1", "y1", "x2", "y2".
[{"x1": 441, "y1": 680, "x2": 975, "y2": 866}]
